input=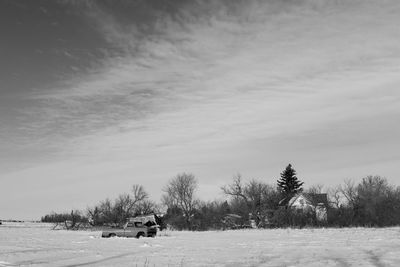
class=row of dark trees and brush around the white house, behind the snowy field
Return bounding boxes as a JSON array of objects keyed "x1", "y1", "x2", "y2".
[{"x1": 42, "y1": 164, "x2": 400, "y2": 230}]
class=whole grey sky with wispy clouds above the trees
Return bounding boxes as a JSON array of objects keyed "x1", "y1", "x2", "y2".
[{"x1": 0, "y1": 0, "x2": 400, "y2": 219}]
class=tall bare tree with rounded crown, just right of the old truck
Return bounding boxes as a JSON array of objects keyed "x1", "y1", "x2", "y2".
[{"x1": 162, "y1": 173, "x2": 198, "y2": 229}]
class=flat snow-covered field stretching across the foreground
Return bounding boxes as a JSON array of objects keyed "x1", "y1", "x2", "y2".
[{"x1": 0, "y1": 223, "x2": 400, "y2": 267}]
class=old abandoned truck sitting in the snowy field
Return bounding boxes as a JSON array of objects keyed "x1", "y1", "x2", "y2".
[{"x1": 101, "y1": 222, "x2": 157, "y2": 238}]
